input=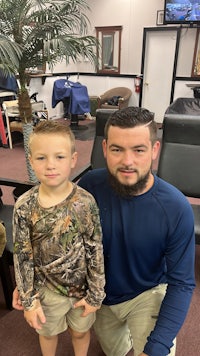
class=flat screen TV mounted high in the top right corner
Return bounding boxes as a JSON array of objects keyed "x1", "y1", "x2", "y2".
[{"x1": 164, "y1": 0, "x2": 200, "y2": 25}]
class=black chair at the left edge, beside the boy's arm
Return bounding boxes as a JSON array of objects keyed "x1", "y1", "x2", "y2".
[{"x1": 0, "y1": 178, "x2": 34, "y2": 309}]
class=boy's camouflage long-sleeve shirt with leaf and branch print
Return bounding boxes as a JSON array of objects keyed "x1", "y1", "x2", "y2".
[{"x1": 13, "y1": 185, "x2": 105, "y2": 310}]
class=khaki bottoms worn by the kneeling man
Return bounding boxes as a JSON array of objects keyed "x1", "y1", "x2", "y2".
[{"x1": 94, "y1": 284, "x2": 176, "y2": 356}]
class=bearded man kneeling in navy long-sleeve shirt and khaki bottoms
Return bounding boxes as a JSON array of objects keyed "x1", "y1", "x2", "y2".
[{"x1": 79, "y1": 107, "x2": 195, "y2": 356}]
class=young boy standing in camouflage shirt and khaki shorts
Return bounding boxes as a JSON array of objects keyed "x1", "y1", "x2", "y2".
[{"x1": 13, "y1": 121, "x2": 105, "y2": 356}]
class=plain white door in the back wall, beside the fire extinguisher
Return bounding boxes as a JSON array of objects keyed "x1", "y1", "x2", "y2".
[{"x1": 141, "y1": 28, "x2": 177, "y2": 123}]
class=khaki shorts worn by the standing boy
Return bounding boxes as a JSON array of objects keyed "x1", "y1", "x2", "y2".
[{"x1": 36, "y1": 288, "x2": 96, "y2": 336}]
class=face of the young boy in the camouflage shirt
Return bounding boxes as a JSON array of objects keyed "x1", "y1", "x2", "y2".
[{"x1": 30, "y1": 134, "x2": 77, "y2": 187}]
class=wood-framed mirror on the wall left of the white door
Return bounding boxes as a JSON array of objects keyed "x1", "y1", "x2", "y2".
[{"x1": 95, "y1": 26, "x2": 122, "y2": 74}]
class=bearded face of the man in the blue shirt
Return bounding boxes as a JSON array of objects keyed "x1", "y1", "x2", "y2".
[{"x1": 103, "y1": 126, "x2": 160, "y2": 194}]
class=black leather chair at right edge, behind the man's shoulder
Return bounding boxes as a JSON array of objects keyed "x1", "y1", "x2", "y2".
[{"x1": 157, "y1": 115, "x2": 200, "y2": 244}]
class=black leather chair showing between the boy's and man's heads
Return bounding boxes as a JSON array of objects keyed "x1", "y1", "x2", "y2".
[{"x1": 72, "y1": 109, "x2": 117, "y2": 182}]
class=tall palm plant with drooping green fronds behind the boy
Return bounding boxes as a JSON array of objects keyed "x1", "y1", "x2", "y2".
[{"x1": 0, "y1": 0, "x2": 97, "y2": 181}]
